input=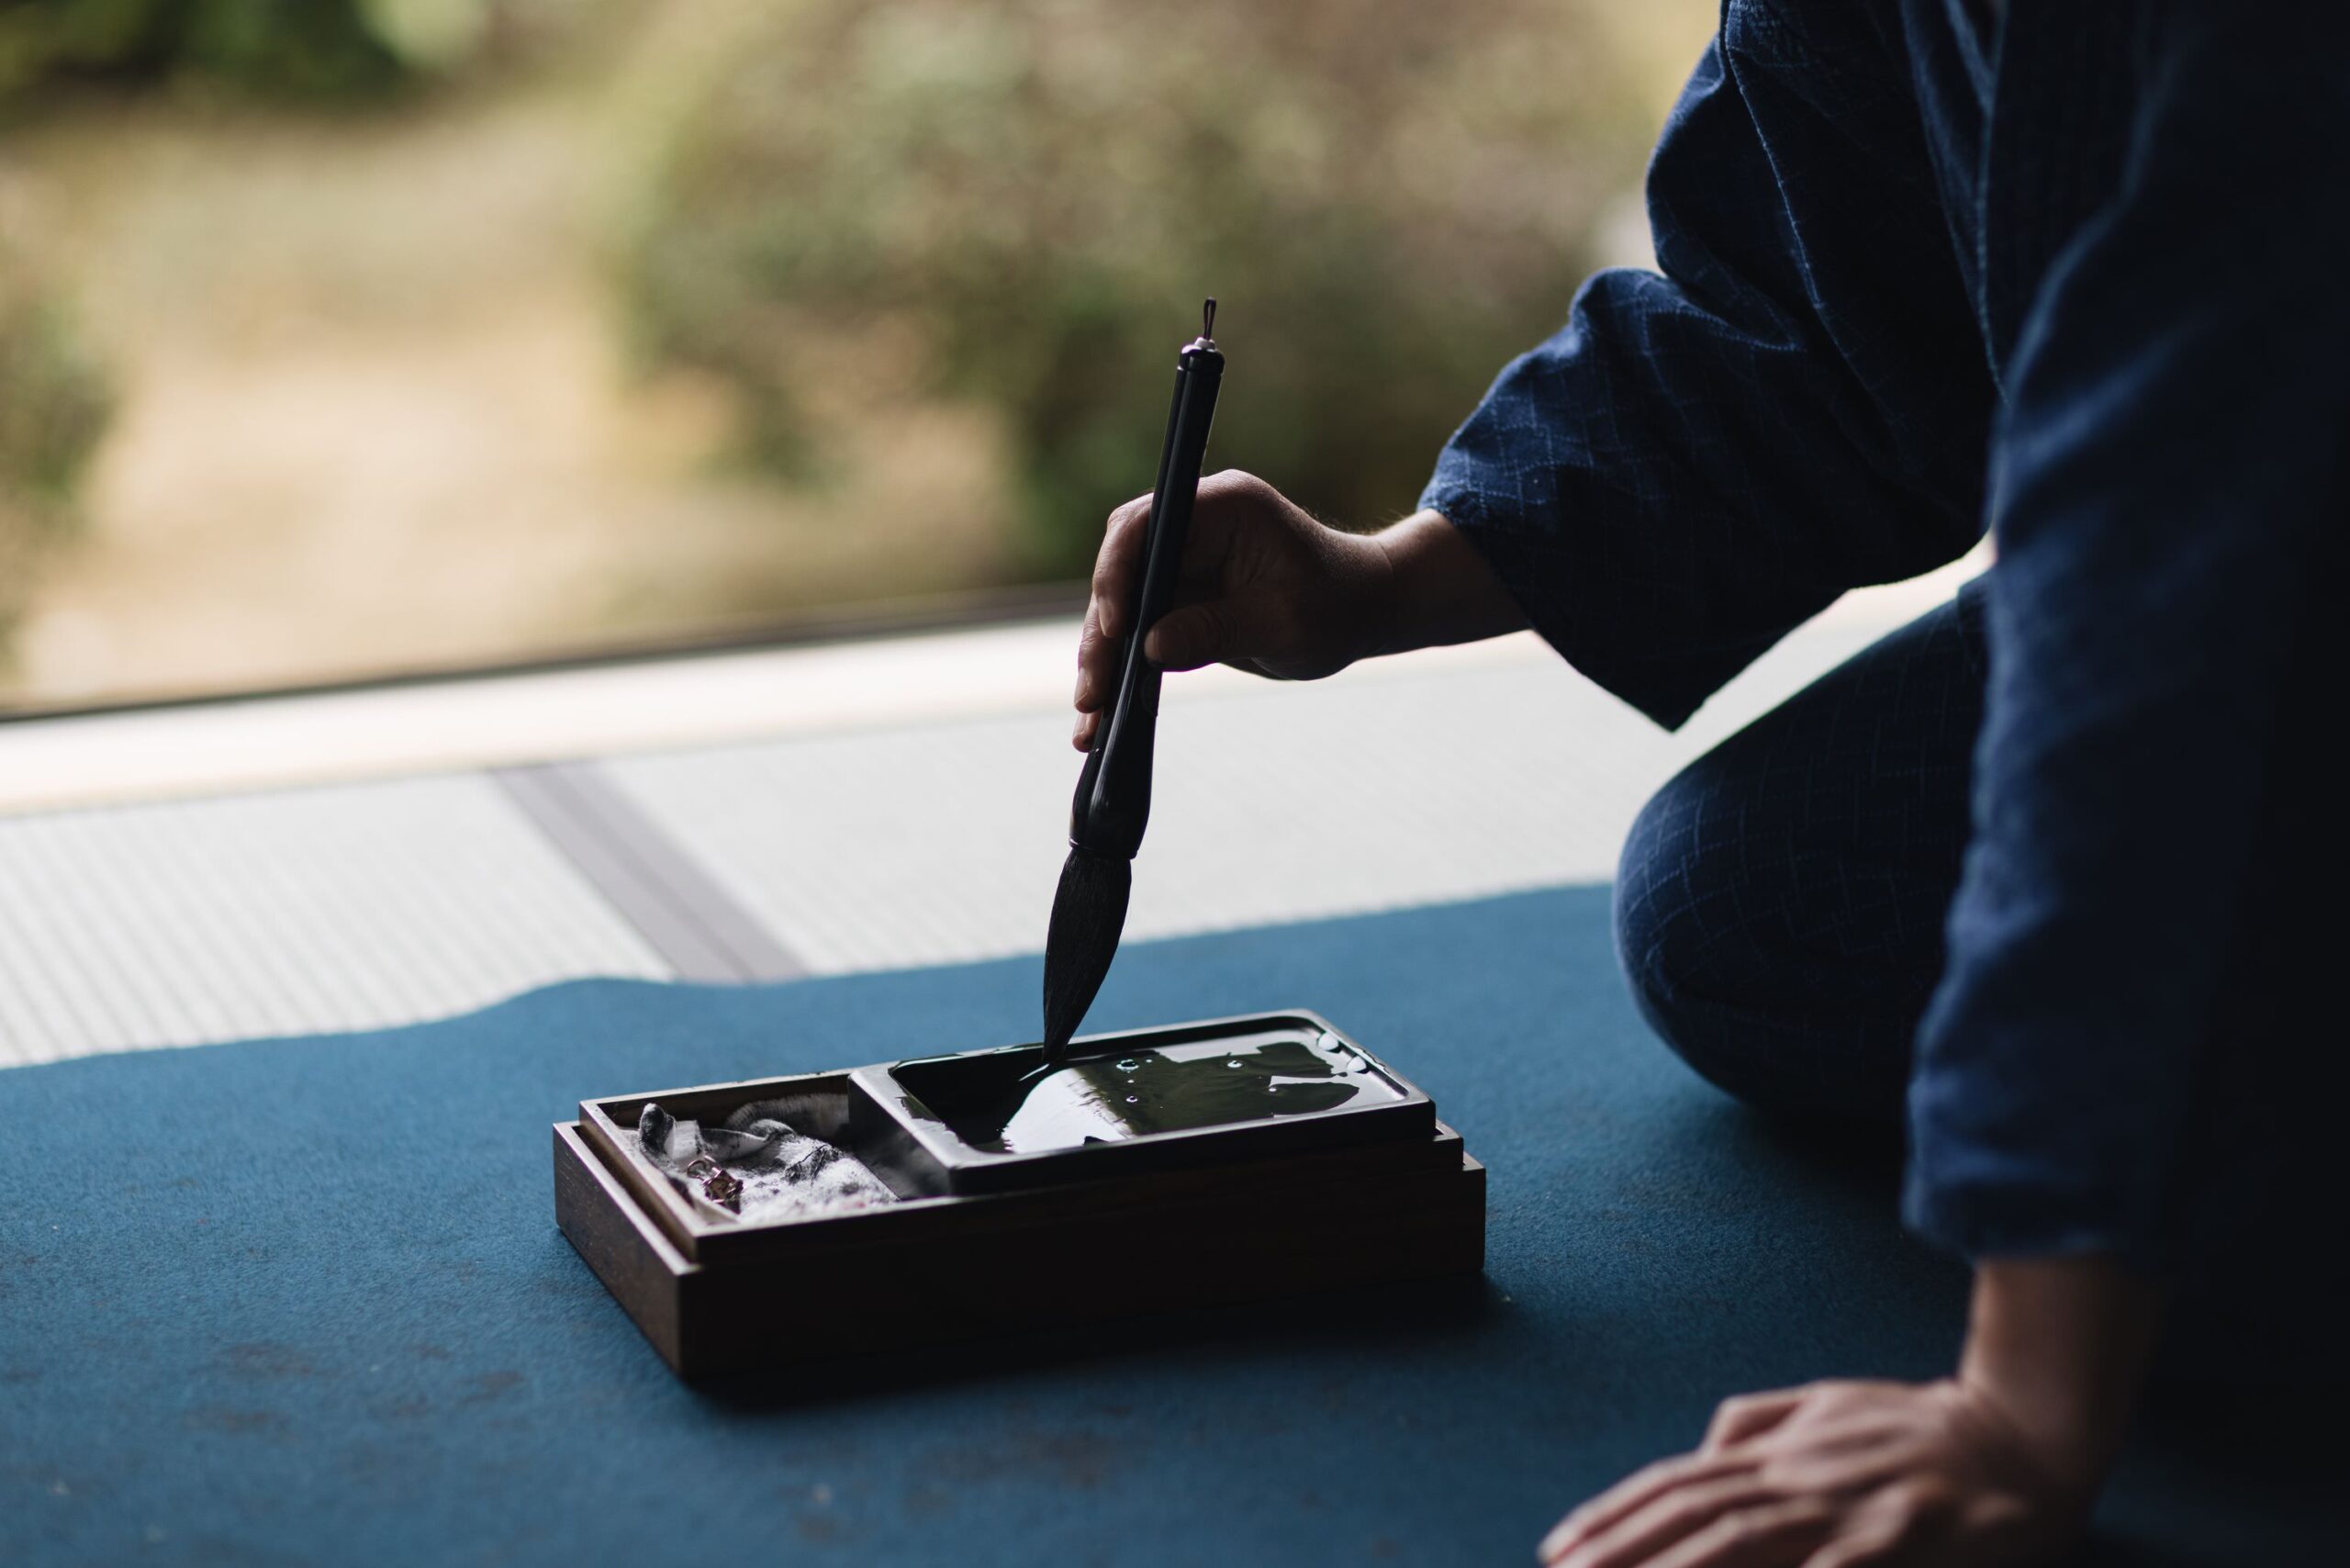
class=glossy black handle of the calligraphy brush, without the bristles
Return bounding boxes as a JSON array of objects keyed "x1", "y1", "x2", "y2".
[{"x1": 1069, "y1": 298, "x2": 1225, "y2": 860}]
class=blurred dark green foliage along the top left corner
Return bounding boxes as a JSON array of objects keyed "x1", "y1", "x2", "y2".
[{"x1": 0, "y1": 0, "x2": 585, "y2": 101}]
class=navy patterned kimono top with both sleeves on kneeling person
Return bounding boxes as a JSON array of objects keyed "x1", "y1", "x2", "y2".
[{"x1": 1422, "y1": 0, "x2": 2350, "y2": 1270}]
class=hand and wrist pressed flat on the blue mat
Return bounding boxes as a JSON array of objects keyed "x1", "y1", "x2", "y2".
[{"x1": 1541, "y1": 1258, "x2": 2157, "y2": 1568}]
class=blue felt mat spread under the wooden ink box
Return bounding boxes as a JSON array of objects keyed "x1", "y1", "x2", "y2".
[{"x1": 0, "y1": 889, "x2": 2326, "y2": 1568}]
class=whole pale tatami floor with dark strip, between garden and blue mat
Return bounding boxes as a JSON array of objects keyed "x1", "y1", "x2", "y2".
[{"x1": 0, "y1": 554, "x2": 1964, "y2": 1065}]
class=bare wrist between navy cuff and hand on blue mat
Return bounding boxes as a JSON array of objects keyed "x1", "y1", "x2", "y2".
[{"x1": 1957, "y1": 1255, "x2": 2162, "y2": 1500}]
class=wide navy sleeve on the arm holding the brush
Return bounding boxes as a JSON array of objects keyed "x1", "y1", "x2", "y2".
[{"x1": 1422, "y1": 3, "x2": 1993, "y2": 724}]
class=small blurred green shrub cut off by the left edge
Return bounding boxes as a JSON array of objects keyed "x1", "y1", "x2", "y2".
[{"x1": 0, "y1": 244, "x2": 110, "y2": 634}]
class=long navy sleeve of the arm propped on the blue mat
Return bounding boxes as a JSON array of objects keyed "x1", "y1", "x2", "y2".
[{"x1": 1906, "y1": 3, "x2": 2350, "y2": 1271}]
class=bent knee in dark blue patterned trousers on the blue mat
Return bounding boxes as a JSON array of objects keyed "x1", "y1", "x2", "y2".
[{"x1": 1615, "y1": 578, "x2": 1986, "y2": 1128}]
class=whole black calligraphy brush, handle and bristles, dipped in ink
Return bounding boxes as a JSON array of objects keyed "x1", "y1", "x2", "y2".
[{"x1": 1044, "y1": 298, "x2": 1225, "y2": 1065}]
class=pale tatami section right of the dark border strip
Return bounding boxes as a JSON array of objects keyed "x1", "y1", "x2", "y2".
[{"x1": 601, "y1": 666, "x2": 1673, "y2": 973}]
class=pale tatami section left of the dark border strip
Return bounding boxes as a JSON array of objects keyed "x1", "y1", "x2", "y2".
[{"x1": 0, "y1": 776, "x2": 667, "y2": 1065}]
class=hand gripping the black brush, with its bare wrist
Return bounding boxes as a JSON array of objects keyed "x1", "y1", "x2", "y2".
[{"x1": 1074, "y1": 470, "x2": 1525, "y2": 750}]
